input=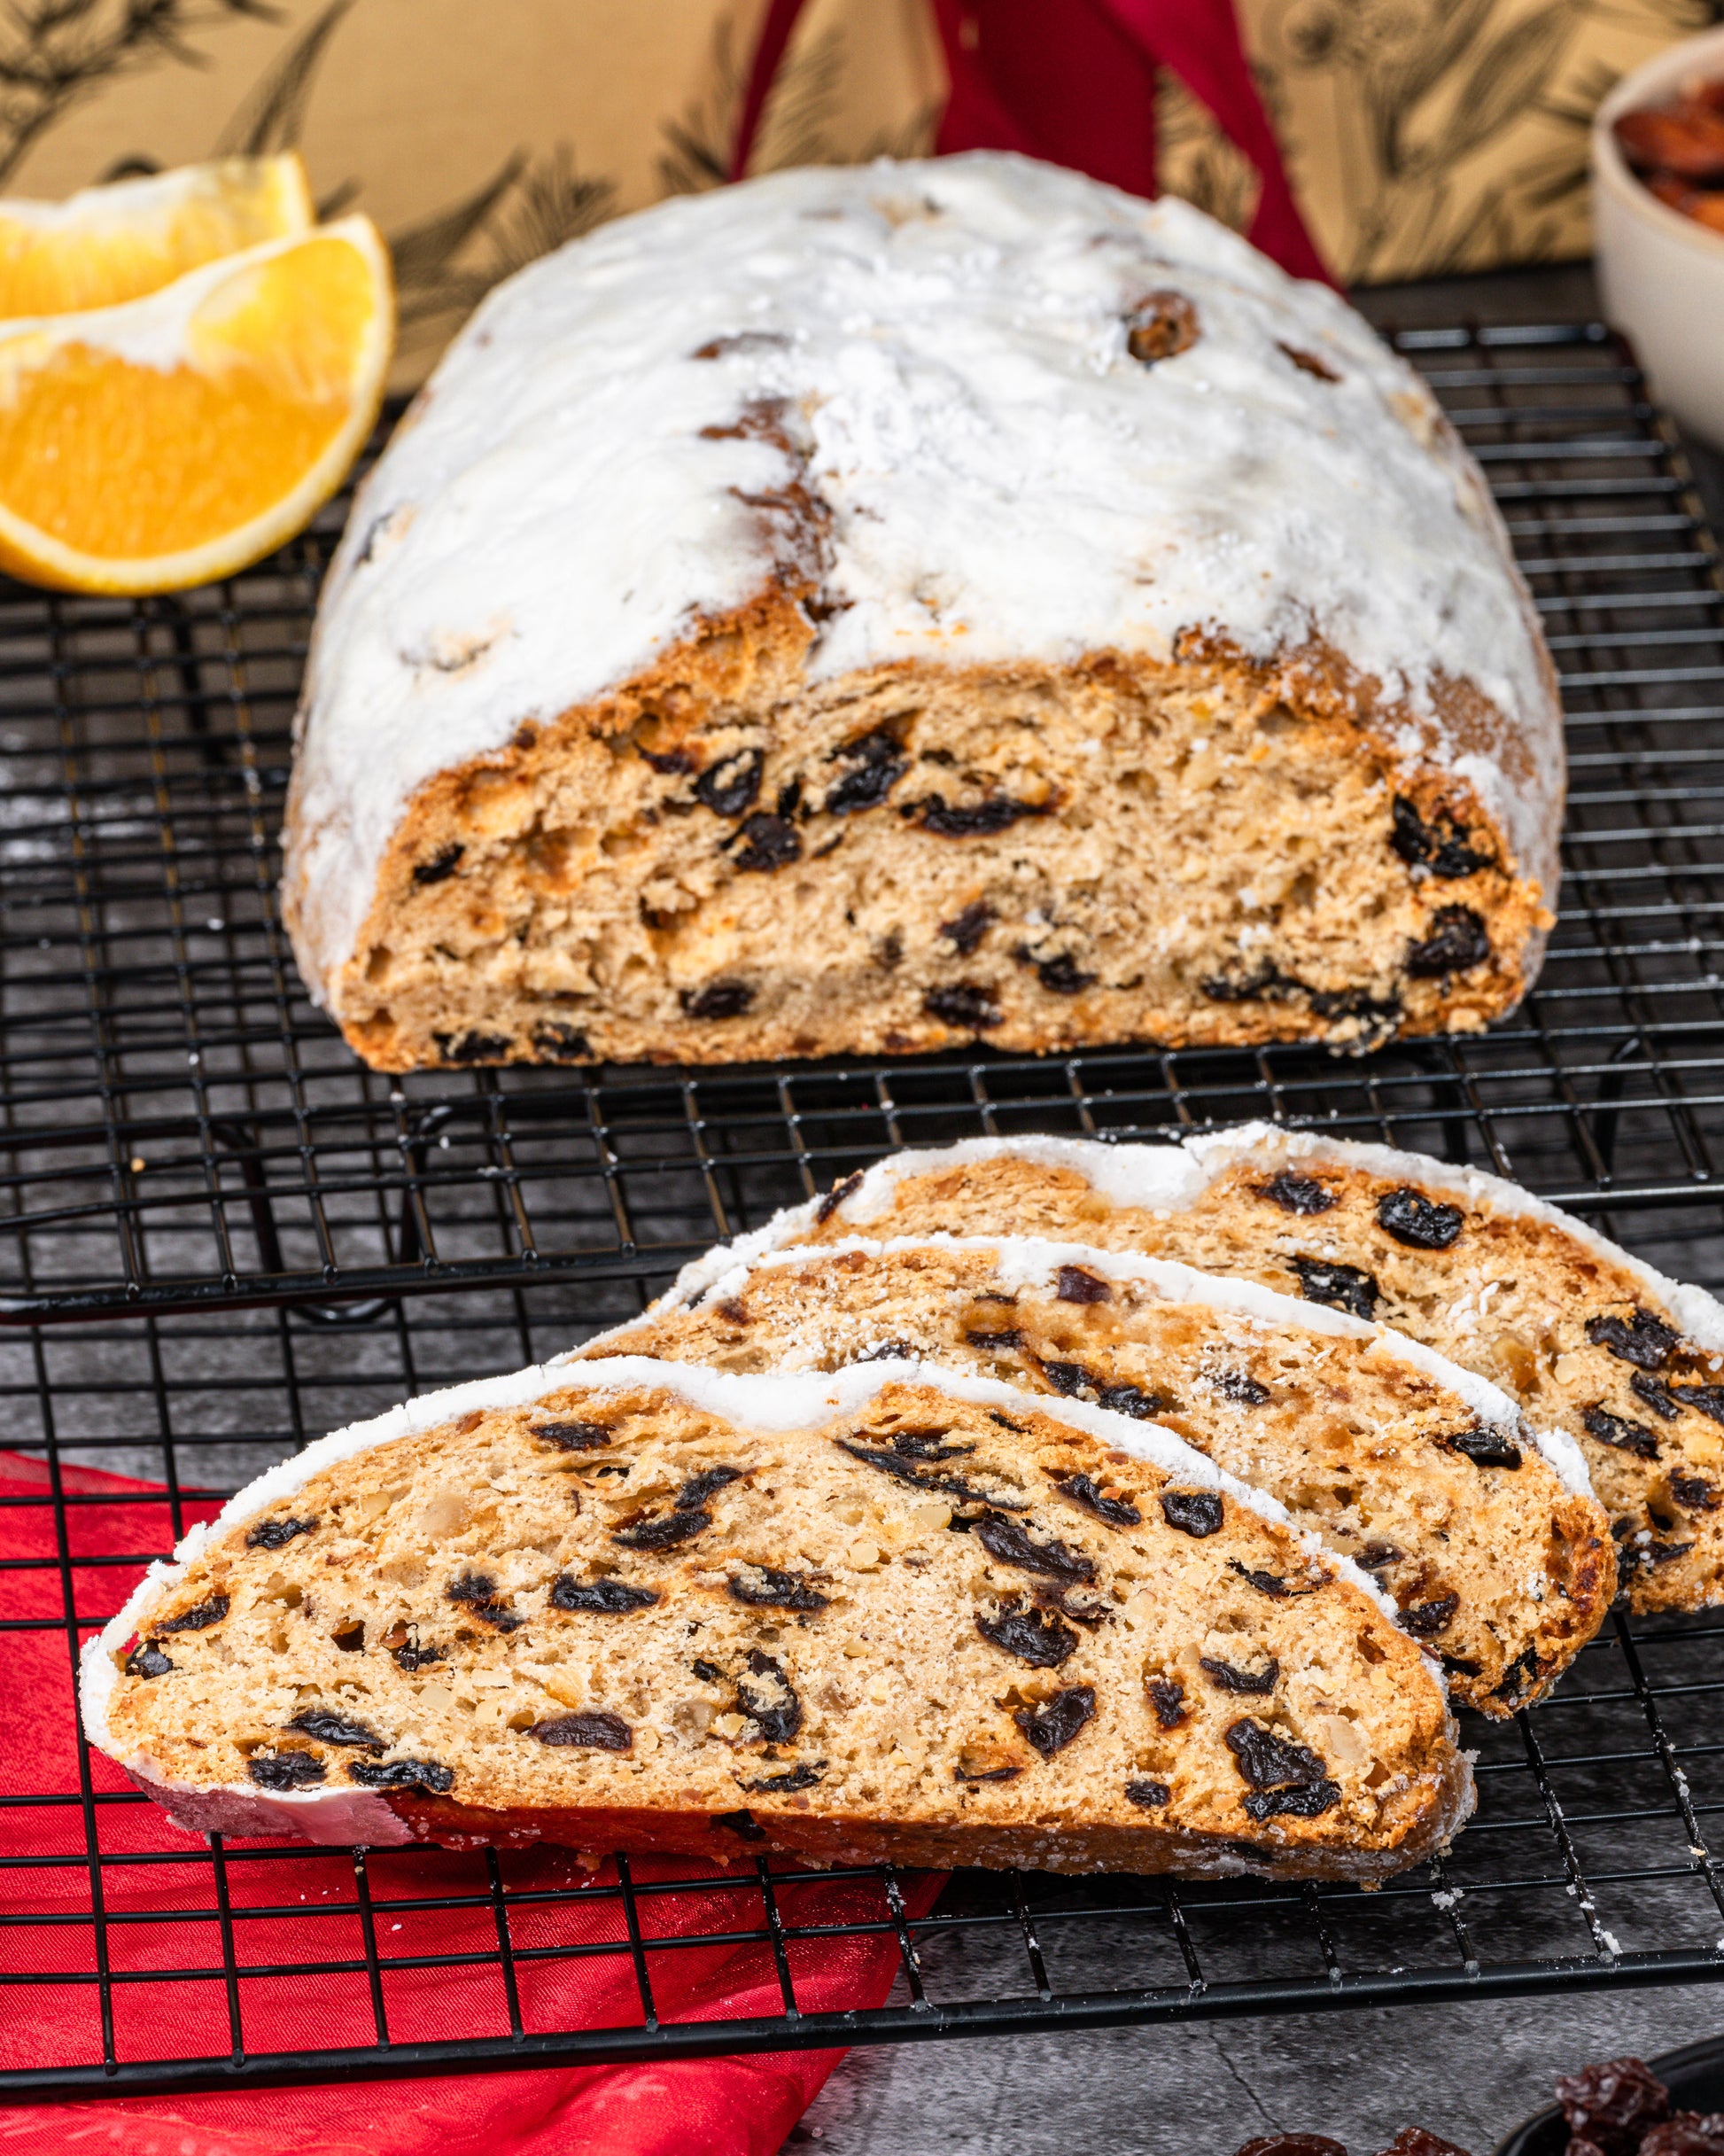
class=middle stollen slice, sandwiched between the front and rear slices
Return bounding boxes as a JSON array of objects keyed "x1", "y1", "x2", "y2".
[{"x1": 582, "y1": 1235, "x2": 1616, "y2": 1716}]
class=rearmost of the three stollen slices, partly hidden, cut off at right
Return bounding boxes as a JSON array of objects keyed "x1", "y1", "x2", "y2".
[{"x1": 694, "y1": 1124, "x2": 1724, "y2": 1610}]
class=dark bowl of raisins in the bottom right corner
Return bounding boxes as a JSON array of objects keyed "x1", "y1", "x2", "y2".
[{"x1": 1495, "y1": 2037, "x2": 1724, "y2": 2156}]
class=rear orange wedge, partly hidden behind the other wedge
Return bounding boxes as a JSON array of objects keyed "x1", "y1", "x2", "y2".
[{"x1": 0, "y1": 151, "x2": 315, "y2": 317}]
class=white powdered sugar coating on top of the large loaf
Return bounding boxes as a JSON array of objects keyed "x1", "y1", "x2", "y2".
[{"x1": 291, "y1": 153, "x2": 1563, "y2": 992}]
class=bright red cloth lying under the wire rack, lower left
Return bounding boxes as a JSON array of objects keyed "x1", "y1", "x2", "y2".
[{"x1": 0, "y1": 1453, "x2": 942, "y2": 2156}]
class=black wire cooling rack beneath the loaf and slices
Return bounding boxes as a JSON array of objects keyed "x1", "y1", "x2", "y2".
[{"x1": 0, "y1": 325, "x2": 1724, "y2": 2098}]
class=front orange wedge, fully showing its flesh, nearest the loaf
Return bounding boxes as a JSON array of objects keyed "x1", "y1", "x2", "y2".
[{"x1": 0, "y1": 218, "x2": 394, "y2": 593}]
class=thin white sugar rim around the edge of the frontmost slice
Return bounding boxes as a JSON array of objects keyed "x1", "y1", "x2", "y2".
[{"x1": 80, "y1": 1356, "x2": 1470, "y2": 1843}]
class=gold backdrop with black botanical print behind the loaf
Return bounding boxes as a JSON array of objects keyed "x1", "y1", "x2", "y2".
[{"x1": 0, "y1": 0, "x2": 1720, "y2": 382}]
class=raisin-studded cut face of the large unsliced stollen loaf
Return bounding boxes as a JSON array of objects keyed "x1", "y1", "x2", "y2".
[{"x1": 289, "y1": 595, "x2": 1549, "y2": 1071}]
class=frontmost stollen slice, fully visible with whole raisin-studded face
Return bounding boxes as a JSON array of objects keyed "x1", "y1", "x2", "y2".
[{"x1": 82, "y1": 1356, "x2": 1472, "y2": 1880}]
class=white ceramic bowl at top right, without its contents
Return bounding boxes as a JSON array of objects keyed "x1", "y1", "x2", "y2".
[{"x1": 1593, "y1": 28, "x2": 1724, "y2": 448}]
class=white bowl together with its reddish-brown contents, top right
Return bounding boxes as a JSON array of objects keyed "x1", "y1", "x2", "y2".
[{"x1": 1593, "y1": 28, "x2": 1724, "y2": 448}]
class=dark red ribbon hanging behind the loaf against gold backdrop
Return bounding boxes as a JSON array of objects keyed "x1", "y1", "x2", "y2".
[{"x1": 731, "y1": 0, "x2": 1334, "y2": 284}]
